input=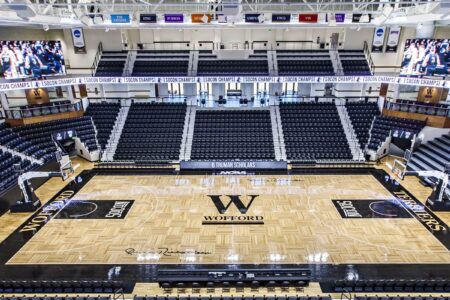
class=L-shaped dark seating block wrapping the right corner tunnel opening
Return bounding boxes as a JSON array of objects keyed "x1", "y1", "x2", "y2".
[{"x1": 367, "y1": 116, "x2": 425, "y2": 150}]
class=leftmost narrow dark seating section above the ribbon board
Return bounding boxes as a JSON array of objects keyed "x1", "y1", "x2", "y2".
[{"x1": 95, "y1": 51, "x2": 128, "y2": 77}]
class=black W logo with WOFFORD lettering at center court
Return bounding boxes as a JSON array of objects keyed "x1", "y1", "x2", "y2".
[{"x1": 202, "y1": 195, "x2": 264, "y2": 225}]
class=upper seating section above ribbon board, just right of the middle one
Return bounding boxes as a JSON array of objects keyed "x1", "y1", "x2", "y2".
[{"x1": 277, "y1": 50, "x2": 335, "y2": 76}]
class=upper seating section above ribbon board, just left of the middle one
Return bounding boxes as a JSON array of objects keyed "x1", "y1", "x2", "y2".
[{"x1": 132, "y1": 50, "x2": 189, "y2": 76}]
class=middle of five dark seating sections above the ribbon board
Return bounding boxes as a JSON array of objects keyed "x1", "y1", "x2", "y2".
[{"x1": 197, "y1": 59, "x2": 269, "y2": 76}]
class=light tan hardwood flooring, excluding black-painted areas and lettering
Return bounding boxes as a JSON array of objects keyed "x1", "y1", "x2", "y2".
[{"x1": 0, "y1": 163, "x2": 450, "y2": 264}]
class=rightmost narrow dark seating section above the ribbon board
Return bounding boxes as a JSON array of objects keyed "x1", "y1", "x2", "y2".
[{"x1": 339, "y1": 50, "x2": 372, "y2": 76}]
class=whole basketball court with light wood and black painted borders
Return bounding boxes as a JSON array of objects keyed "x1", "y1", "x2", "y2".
[{"x1": 2, "y1": 169, "x2": 450, "y2": 265}]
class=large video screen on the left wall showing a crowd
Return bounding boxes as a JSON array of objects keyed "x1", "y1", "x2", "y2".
[{"x1": 0, "y1": 41, "x2": 66, "y2": 79}]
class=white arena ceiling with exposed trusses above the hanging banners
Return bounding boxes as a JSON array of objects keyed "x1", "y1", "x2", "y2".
[{"x1": 0, "y1": 0, "x2": 450, "y2": 27}]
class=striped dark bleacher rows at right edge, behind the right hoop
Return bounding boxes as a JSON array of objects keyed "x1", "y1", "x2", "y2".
[{"x1": 406, "y1": 134, "x2": 450, "y2": 195}]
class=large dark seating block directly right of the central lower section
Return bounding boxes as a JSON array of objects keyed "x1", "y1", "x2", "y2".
[{"x1": 280, "y1": 103, "x2": 352, "y2": 161}]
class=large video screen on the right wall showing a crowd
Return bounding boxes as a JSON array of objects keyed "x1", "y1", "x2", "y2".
[{"x1": 400, "y1": 39, "x2": 450, "y2": 76}]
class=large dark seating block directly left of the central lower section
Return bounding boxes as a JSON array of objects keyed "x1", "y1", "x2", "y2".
[{"x1": 114, "y1": 103, "x2": 186, "y2": 161}]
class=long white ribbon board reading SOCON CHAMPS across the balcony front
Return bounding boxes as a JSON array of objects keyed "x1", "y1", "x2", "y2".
[{"x1": 0, "y1": 76, "x2": 450, "y2": 91}]
